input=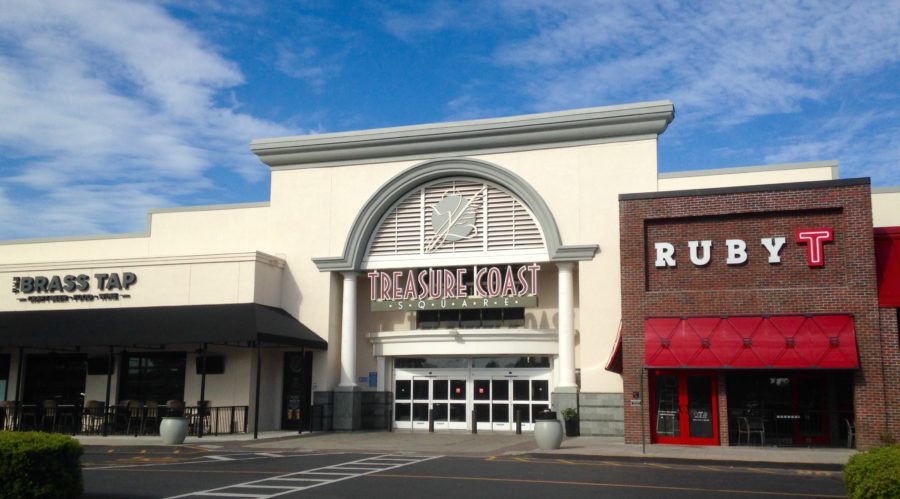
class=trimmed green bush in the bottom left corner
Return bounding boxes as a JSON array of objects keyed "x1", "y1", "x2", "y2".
[{"x1": 0, "y1": 431, "x2": 83, "y2": 498}]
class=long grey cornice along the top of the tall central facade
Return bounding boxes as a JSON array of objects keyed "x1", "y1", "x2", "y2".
[{"x1": 250, "y1": 101, "x2": 675, "y2": 170}]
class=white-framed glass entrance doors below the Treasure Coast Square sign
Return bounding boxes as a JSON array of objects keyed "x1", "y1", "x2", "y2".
[{"x1": 394, "y1": 356, "x2": 550, "y2": 431}]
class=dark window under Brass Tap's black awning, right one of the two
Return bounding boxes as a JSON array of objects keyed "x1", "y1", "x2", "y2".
[{"x1": 119, "y1": 352, "x2": 185, "y2": 404}]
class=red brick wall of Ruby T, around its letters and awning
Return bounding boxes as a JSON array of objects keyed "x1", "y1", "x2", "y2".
[{"x1": 619, "y1": 179, "x2": 900, "y2": 448}]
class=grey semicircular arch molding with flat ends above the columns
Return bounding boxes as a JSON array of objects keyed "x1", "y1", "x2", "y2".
[{"x1": 313, "y1": 158, "x2": 599, "y2": 272}]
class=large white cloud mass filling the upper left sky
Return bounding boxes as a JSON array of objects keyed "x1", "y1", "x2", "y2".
[{"x1": 0, "y1": 0, "x2": 297, "y2": 239}]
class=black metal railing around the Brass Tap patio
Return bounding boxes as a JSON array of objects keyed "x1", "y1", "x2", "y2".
[{"x1": 0, "y1": 403, "x2": 248, "y2": 436}]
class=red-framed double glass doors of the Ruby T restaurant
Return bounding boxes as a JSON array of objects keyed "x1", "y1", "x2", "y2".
[{"x1": 650, "y1": 371, "x2": 719, "y2": 445}]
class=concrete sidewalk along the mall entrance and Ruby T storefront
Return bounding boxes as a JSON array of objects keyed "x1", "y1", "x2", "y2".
[{"x1": 76, "y1": 431, "x2": 856, "y2": 469}]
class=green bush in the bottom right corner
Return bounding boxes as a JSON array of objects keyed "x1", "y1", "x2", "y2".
[{"x1": 844, "y1": 445, "x2": 900, "y2": 499}]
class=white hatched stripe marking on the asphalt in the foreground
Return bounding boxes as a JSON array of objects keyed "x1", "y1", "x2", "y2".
[{"x1": 169, "y1": 454, "x2": 442, "y2": 499}]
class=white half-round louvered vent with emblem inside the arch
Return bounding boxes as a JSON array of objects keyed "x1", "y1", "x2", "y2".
[{"x1": 368, "y1": 179, "x2": 544, "y2": 257}]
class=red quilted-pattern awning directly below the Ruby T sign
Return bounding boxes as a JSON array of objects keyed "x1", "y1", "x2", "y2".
[{"x1": 644, "y1": 315, "x2": 859, "y2": 369}]
